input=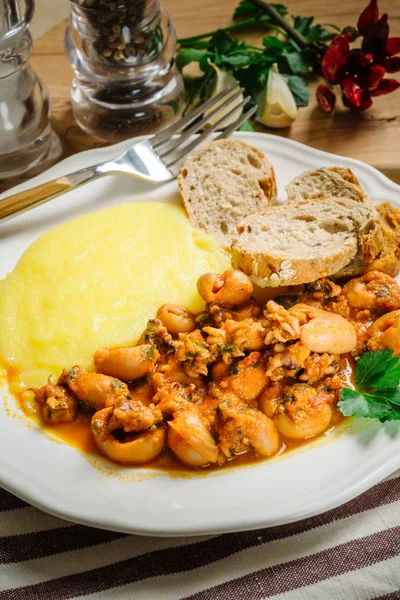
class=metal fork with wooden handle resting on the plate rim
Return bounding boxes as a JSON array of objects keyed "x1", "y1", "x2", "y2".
[{"x1": 0, "y1": 82, "x2": 256, "y2": 223}]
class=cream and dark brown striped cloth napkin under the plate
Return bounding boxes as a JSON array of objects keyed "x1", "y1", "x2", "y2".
[{"x1": 0, "y1": 471, "x2": 400, "y2": 600}]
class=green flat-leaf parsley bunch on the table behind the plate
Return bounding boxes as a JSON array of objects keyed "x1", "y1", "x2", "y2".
[{"x1": 176, "y1": 0, "x2": 340, "y2": 123}]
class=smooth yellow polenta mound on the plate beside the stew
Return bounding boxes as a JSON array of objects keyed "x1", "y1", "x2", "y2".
[{"x1": 0, "y1": 202, "x2": 230, "y2": 386}]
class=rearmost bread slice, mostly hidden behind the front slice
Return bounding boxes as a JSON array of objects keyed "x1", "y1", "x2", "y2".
[{"x1": 286, "y1": 167, "x2": 368, "y2": 202}]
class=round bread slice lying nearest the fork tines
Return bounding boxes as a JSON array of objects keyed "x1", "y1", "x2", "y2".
[{"x1": 178, "y1": 140, "x2": 276, "y2": 248}]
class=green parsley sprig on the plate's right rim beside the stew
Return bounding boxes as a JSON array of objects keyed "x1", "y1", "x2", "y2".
[{"x1": 338, "y1": 350, "x2": 400, "y2": 423}]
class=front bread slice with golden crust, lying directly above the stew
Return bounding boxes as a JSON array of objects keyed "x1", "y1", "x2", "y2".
[{"x1": 232, "y1": 198, "x2": 383, "y2": 287}]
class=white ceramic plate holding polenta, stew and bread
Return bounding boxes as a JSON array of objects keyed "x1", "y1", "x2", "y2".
[{"x1": 0, "y1": 133, "x2": 400, "y2": 536}]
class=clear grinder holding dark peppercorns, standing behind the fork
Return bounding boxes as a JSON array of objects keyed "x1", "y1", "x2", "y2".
[{"x1": 65, "y1": 0, "x2": 184, "y2": 143}]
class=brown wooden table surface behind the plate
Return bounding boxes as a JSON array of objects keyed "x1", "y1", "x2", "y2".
[{"x1": 32, "y1": 0, "x2": 400, "y2": 183}]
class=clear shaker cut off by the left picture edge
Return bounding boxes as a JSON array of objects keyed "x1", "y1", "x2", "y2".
[{"x1": 0, "y1": 0, "x2": 62, "y2": 192}]
